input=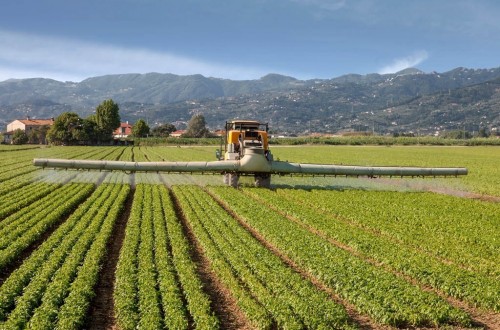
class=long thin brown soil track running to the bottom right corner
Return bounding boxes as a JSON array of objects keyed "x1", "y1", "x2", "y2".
[{"x1": 240, "y1": 189, "x2": 500, "y2": 330}]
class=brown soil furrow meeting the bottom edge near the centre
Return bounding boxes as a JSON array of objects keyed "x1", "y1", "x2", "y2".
[{"x1": 171, "y1": 188, "x2": 252, "y2": 330}]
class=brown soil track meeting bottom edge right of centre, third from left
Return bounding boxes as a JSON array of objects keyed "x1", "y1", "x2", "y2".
[{"x1": 205, "y1": 190, "x2": 378, "y2": 330}]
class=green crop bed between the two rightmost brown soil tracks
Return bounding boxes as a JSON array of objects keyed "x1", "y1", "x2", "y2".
[{"x1": 245, "y1": 188, "x2": 500, "y2": 311}]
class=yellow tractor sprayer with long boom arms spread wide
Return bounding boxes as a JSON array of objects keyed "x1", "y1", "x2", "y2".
[{"x1": 33, "y1": 120, "x2": 467, "y2": 187}]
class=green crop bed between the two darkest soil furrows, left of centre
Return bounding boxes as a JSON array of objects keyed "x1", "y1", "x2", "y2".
[{"x1": 114, "y1": 184, "x2": 218, "y2": 329}]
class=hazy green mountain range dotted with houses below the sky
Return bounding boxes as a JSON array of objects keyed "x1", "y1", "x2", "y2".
[{"x1": 0, "y1": 68, "x2": 500, "y2": 134}]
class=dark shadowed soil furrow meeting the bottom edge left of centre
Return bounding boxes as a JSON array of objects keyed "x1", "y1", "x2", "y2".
[{"x1": 84, "y1": 189, "x2": 134, "y2": 330}]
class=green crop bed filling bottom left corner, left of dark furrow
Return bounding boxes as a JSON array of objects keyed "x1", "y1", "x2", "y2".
[{"x1": 0, "y1": 185, "x2": 129, "y2": 329}]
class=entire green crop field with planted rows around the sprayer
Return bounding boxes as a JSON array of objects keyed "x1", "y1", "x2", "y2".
[{"x1": 0, "y1": 146, "x2": 500, "y2": 329}]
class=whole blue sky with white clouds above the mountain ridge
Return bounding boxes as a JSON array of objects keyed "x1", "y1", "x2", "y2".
[{"x1": 0, "y1": 0, "x2": 500, "y2": 82}]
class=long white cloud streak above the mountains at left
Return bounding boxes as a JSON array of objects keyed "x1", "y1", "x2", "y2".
[{"x1": 0, "y1": 30, "x2": 268, "y2": 82}]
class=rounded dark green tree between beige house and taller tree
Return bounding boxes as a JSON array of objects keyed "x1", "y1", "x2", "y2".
[{"x1": 47, "y1": 112, "x2": 83, "y2": 145}]
